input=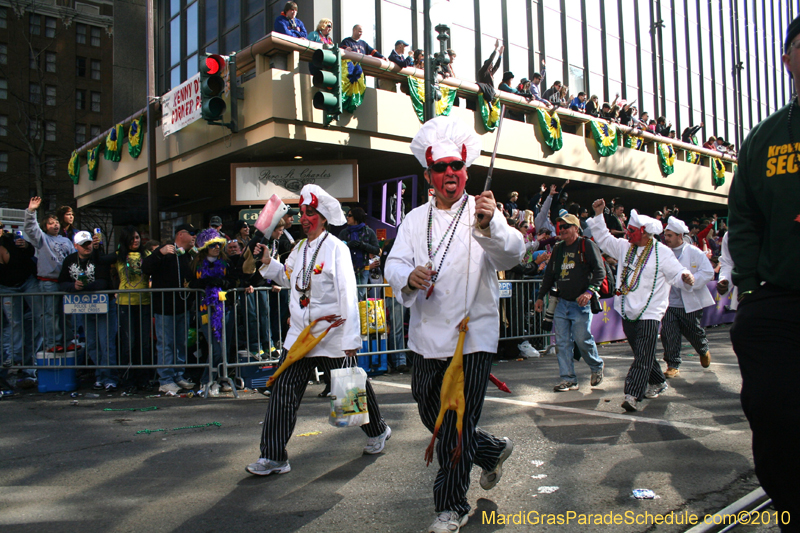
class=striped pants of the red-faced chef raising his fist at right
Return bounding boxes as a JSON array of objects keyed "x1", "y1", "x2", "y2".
[{"x1": 622, "y1": 320, "x2": 667, "y2": 400}]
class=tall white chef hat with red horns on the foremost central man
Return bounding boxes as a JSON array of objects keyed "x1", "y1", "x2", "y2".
[{"x1": 411, "y1": 116, "x2": 483, "y2": 168}]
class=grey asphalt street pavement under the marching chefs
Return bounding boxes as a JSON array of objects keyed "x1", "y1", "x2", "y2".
[{"x1": 0, "y1": 326, "x2": 777, "y2": 533}]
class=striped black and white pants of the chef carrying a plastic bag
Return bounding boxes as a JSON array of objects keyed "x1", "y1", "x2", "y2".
[{"x1": 261, "y1": 350, "x2": 386, "y2": 461}]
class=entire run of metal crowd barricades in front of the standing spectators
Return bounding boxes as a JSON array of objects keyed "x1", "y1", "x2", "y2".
[{"x1": 0, "y1": 274, "x2": 551, "y2": 396}]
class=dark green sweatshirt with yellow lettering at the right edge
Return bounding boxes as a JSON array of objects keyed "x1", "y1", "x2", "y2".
[{"x1": 728, "y1": 105, "x2": 800, "y2": 294}]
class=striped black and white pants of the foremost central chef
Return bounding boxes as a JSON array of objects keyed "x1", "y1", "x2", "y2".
[{"x1": 411, "y1": 352, "x2": 506, "y2": 515}]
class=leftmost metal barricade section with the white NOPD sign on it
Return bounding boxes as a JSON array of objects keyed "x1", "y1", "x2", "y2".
[{"x1": 0, "y1": 289, "x2": 214, "y2": 394}]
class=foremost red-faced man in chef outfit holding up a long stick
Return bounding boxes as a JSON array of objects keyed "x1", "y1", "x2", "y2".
[{"x1": 386, "y1": 116, "x2": 525, "y2": 533}]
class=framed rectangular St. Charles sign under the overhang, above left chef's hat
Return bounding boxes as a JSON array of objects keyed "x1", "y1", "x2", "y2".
[{"x1": 231, "y1": 160, "x2": 358, "y2": 205}]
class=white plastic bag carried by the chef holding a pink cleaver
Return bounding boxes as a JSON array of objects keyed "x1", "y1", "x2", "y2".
[{"x1": 328, "y1": 366, "x2": 369, "y2": 428}]
